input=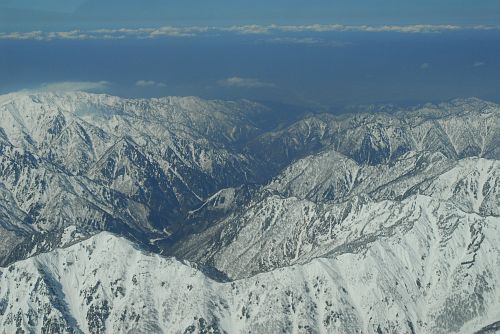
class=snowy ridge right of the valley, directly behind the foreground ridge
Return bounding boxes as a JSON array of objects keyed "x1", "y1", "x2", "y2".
[{"x1": 175, "y1": 152, "x2": 500, "y2": 279}]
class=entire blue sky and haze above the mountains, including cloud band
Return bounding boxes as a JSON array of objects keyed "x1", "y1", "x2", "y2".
[{"x1": 0, "y1": 0, "x2": 500, "y2": 107}]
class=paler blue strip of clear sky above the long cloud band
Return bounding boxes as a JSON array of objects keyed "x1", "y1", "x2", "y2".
[{"x1": 0, "y1": 0, "x2": 500, "y2": 32}]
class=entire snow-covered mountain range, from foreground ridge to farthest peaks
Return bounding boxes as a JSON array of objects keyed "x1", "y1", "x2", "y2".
[{"x1": 0, "y1": 92, "x2": 500, "y2": 334}]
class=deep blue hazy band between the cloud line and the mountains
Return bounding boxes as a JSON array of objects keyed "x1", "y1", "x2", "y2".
[{"x1": 0, "y1": 30, "x2": 500, "y2": 107}]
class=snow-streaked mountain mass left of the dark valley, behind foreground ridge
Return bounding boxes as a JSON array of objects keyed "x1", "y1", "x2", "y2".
[{"x1": 0, "y1": 93, "x2": 284, "y2": 263}]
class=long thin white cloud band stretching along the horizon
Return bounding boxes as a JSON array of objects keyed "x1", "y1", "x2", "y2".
[{"x1": 0, "y1": 24, "x2": 500, "y2": 40}]
